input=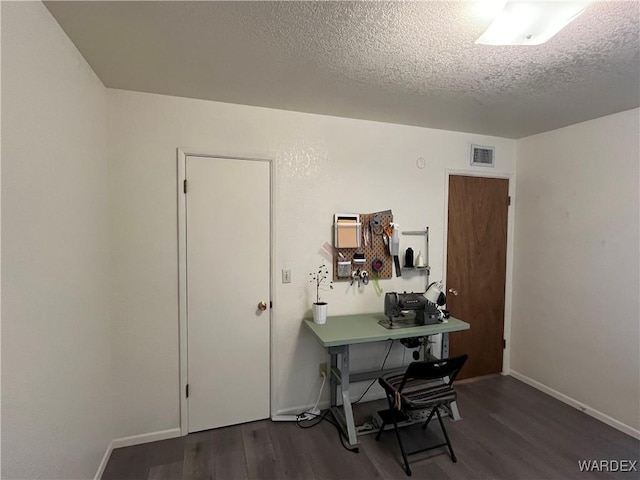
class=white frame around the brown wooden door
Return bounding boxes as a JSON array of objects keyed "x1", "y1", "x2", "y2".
[{"x1": 442, "y1": 168, "x2": 515, "y2": 375}]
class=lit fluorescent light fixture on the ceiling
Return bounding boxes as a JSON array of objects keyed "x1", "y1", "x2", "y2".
[{"x1": 476, "y1": 0, "x2": 592, "y2": 45}]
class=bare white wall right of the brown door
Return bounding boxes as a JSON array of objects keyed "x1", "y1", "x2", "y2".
[{"x1": 511, "y1": 109, "x2": 640, "y2": 432}]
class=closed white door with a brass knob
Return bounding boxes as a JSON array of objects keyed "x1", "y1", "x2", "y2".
[{"x1": 185, "y1": 155, "x2": 270, "y2": 432}]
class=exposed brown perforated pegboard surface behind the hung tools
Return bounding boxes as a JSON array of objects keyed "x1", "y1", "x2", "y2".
[{"x1": 333, "y1": 210, "x2": 394, "y2": 282}]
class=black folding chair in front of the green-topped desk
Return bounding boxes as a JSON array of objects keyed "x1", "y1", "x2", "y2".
[{"x1": 376, "y1": 355, "x2": 467, "y2": 475}]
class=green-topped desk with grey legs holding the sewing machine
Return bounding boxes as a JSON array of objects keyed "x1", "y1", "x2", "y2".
[{"x1": 304, "y1": 313, "x2": 469, "y2": 448}]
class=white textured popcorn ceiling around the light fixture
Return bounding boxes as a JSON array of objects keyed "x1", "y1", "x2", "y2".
[{"x1": 45, "y1": 1, "x2": 640, "y2": 138}]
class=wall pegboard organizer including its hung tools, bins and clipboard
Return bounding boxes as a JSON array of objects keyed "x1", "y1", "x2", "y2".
[{"x1": 333, "y1": 210, "x2": 393, "y2": 281}]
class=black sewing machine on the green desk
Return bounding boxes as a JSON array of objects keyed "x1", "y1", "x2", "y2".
[{"x1": 378, "y1": 292, "x2": 443, "y2": 329}]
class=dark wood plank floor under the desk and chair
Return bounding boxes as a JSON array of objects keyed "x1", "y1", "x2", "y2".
[{"x1": 102, "y1": 376, "x2": 640, "y2": 480}]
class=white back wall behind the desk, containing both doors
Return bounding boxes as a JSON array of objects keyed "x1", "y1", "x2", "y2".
[{"x1": 108, "y1": 90, "x2": 515, "y2": 435}]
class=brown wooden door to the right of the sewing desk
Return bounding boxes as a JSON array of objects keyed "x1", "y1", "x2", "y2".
[{"x1": 447, "y1": 175, "x2": 509, "y2": 378}]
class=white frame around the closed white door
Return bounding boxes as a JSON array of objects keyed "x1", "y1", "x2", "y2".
[{"x1": 176, "y1": 148, "x2": 276, "y2": 436}]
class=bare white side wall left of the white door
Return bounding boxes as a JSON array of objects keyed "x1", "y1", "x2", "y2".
[{"x1": 2, "y1": 2, "x2": 116, "y2": 479}]
